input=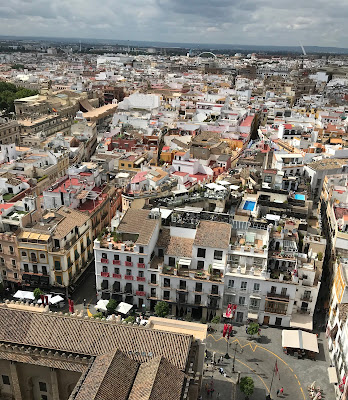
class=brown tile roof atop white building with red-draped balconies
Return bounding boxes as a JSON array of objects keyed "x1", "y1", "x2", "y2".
[{"x1": 117, "y1": 208, "x2": 159, "y2": 245}]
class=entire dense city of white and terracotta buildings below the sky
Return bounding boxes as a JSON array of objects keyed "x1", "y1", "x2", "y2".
[{"x1": 0, "y1": 38, "x2": 348, "y2": 400}]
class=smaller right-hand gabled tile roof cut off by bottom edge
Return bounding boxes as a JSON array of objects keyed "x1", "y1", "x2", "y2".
[{"x1": 129, "y1": 357, "x2": 185, "y2": 400}]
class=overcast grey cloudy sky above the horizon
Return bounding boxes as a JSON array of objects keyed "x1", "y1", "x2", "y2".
[{"x1": 0, "y1": 0, "x2": 348, "y2": 47}]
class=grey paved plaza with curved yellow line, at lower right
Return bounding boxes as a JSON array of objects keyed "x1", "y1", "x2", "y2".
[{"x1": 203, "y1": 325, "x2": 334, "y2": 400}]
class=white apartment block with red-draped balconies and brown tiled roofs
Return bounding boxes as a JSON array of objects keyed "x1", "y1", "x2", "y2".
[{"x1": 94, "y1": 209, "x2": 231, "y2": 318}]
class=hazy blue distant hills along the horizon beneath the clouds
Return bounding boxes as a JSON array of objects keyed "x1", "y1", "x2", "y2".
[{"x1": 0, "y1": 35, "x2": 348, "y2": 54}]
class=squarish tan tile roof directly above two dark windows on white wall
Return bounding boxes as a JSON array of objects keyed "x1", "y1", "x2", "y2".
[{"x1": 194, "y1": 221, "x2": 231, "y2": 249}]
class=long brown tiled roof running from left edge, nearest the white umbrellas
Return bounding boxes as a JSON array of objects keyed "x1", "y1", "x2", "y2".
[{"x1": 0, "y1": 306, "x2": 192, "y2": 370}]
